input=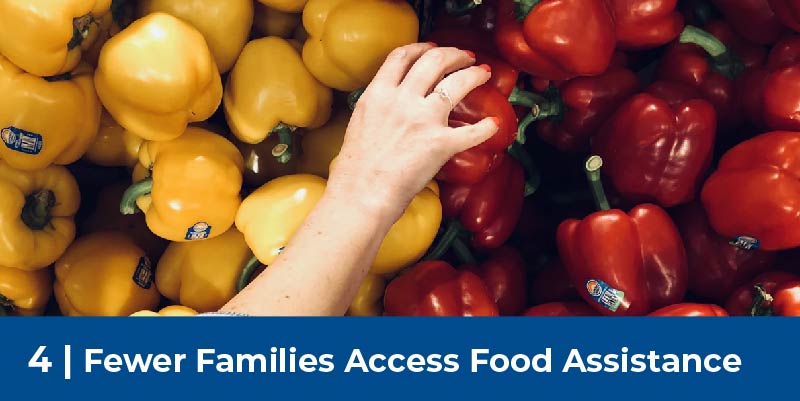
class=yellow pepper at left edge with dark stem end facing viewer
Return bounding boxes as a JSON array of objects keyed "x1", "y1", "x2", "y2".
[{"x1": 0, "y1": 160, "x2": 81, "y2": 270}]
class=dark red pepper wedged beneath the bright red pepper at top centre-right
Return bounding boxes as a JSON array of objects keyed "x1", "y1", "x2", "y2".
[{"x1": 535, "y1": 67, "x2": 640, "y2": 152}]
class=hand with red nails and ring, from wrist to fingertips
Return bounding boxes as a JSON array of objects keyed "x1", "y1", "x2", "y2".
[{"x1": 328, "y1": 43, "x2": 498, "y2": 221}]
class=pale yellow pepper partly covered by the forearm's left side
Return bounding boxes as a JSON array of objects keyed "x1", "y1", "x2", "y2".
[{"x1": 236, "y1": 174, "x2": 325, "y2": 266}]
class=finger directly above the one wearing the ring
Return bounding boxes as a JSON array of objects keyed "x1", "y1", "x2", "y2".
[{"x1": 400, "y1": 47, "x2": 475, "y2": 96}]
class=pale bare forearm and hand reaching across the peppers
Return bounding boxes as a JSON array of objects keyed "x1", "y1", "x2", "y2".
[{"x1": 220, "y1": 43, "x2": 498, "y2": 316}]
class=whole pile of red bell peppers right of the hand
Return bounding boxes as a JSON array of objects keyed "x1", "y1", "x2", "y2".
[{"x1": 384, "y1": 0, "x2": 800, "y2": 316}]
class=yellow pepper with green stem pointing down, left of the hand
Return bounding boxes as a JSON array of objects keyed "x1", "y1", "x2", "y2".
[{"x1": 223, "y1": 36, "x2": 333, "y2": 163}]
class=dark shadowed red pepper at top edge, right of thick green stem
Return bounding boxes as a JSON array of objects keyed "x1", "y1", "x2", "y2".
[{"x1": 712, "y1": 0, "x2": 786, "y2": 45}]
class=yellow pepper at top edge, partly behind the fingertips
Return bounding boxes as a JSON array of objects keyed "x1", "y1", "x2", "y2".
[{"x1": 303, "y1": 0, "x2": 419, "y2": 92}]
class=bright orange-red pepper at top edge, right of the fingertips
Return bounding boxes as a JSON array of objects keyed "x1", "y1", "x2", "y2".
[{"x1": 494, "y1": 0, "x2": 617, "y2": 81}]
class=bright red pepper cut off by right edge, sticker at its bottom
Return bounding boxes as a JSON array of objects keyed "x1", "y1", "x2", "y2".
[{"x1": 701, "y1": 131, "x2": 800, "y2": 251}]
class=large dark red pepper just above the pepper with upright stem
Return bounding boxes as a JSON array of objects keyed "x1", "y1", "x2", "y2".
[{"x1": 592, "y1": 93, "x2": 716, "y2": 207}]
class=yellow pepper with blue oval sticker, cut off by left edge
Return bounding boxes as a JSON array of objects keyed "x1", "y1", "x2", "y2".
[{"x1": 0, "y1": 56, "x2": 101, "y2": 170}]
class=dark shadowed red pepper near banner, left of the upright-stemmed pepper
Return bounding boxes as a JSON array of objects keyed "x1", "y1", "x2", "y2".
[{"x1": 462, "y1": 246, "x2": 528, "y2": 316}]
